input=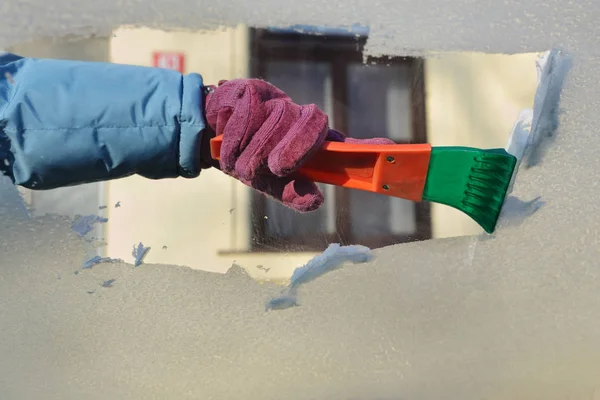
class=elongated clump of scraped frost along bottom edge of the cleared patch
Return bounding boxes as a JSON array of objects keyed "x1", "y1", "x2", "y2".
[{"x1": 265, "y1": 243, "x2": 373, "y2": 311}]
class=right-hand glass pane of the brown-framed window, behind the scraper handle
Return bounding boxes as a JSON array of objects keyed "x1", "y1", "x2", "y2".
[{"x1": 348, "y1": 63, "x2": 417, "y2": 238}]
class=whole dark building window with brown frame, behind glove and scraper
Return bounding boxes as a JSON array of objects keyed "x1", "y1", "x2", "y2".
[{"x1": 251, "y1": 29, "x2": 431, "y2": 251}]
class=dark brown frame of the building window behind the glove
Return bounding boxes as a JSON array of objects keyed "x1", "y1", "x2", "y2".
[{"x1": 249, "y1": 28, "x2": 432, "y2": 252}]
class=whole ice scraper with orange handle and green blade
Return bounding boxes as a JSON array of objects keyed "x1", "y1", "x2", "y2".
[{"x1": 211, "y1": 135, "x2": 517, "y2": 233}]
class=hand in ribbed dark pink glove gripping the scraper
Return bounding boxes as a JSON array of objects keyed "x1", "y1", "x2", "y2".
[{"x1": 205, "y1": 79, "x2": 394, "y2": 212}]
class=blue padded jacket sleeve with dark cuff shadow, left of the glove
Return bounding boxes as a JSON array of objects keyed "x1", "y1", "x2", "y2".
[{"x1": 0, "y1": 54, "x2": 205, "y2": 189}]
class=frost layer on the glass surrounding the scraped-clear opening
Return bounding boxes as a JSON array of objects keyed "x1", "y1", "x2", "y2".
[{"x1": 0, "y1": 0, "x2": 600, "y2": 400}]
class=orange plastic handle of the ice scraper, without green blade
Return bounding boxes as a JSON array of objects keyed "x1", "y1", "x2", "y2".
[{"x1": 210, "y1": 135, "x2": 431, "y2": 201}]
